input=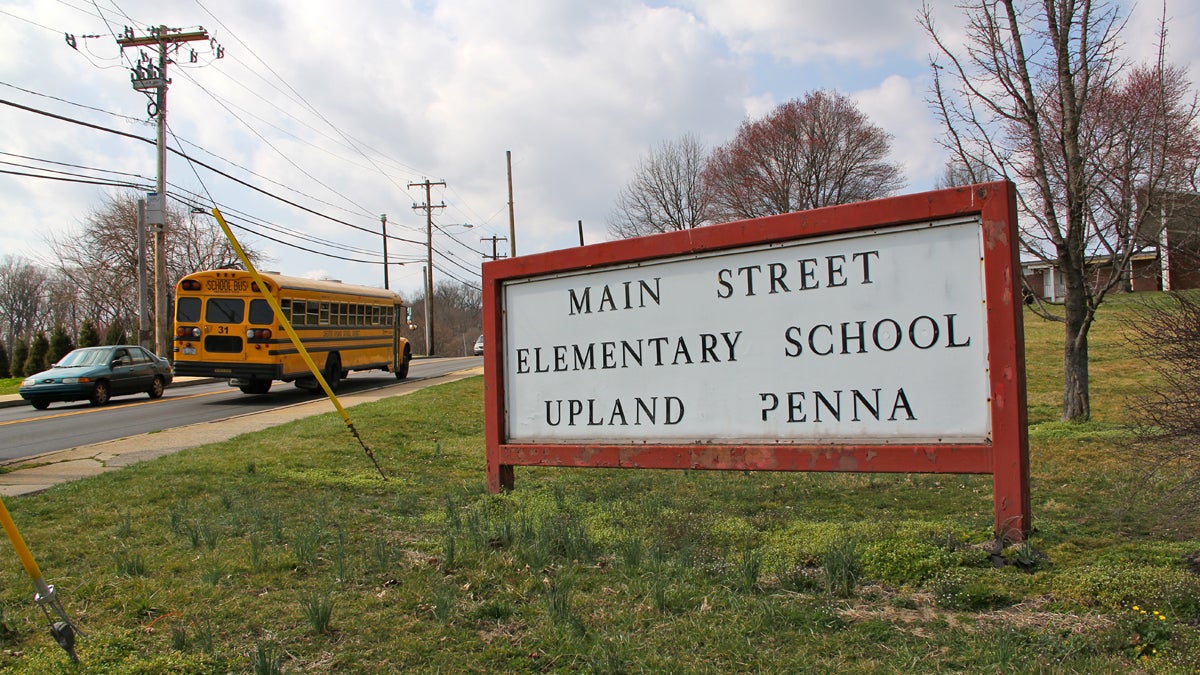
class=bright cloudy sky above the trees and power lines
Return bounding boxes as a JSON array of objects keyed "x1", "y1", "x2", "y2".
[{"x1": 0, "y1": 0, "x2": 1200, "y2": 295}]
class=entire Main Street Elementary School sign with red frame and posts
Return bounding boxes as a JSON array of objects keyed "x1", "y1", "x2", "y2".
[{"x1": 484, "y1": 183, "x2": 1030, "y2": 539}]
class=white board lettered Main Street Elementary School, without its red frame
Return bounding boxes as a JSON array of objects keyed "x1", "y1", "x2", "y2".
[{"x1": 503, "y1": 217, "x2": 991, "y2": 444}]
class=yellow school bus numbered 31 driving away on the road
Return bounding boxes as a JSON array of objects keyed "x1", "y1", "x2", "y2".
[{"x1": 173, "y1": 269, "x2": 413, "y2": 394}]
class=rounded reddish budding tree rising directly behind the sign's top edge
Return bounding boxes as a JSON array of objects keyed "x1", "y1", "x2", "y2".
[{"x1": 704, "y1": 91, "x2": 904, "y2": 220}]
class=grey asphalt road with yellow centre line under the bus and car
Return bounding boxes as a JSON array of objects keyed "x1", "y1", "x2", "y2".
[{"x1": 0, "y1": 357, "x2": 482, "y2": 462}]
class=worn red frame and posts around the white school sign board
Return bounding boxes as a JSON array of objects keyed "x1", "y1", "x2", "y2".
[{"x1": 484, "y1": 181, "x2": 1030, "y2": 542}]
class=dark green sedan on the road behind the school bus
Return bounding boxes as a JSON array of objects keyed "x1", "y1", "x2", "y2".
[{"x1": 18, "y1": 345, "x2": 174, "y2": 410}]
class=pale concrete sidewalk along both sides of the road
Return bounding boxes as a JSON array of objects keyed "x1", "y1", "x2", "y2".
[{"x1": 0, "y1": 368, "x2": 484, "y2": 497}]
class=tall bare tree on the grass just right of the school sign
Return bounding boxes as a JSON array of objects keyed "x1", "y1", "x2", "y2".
[{"x1": 920, "y1": 0, "x2": 1196, "y2": 420}]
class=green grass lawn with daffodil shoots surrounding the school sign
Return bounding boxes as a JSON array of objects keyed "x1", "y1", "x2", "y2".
[{"x1": 0, "y1": 293, "x2": 1200, "y2": 674}]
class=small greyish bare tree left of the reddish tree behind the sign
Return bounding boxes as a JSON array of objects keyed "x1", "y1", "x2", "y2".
[{"x1": 608, "y1": 133, "x2": 709, "y2": 239}]
